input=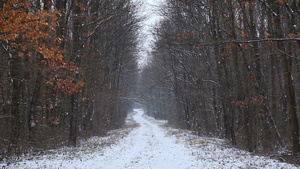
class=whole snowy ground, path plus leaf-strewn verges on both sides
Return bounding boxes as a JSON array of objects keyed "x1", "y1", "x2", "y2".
[{"x1": 0, "y1": 109, "x2": 298, "y2": 169}]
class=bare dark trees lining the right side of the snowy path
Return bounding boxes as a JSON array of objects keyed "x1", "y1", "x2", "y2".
[{"x1": 144, "y1": 0, "x2": 300, "y2": 153}]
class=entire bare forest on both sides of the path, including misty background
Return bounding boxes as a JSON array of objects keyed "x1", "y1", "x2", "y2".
[{"x1": 0, "y1": 0, "x2": 300, "y2": 161}]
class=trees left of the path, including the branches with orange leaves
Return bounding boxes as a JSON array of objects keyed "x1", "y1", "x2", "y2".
[{"x1": 0, "y1": 0, "x2": 139, "y2": 158}]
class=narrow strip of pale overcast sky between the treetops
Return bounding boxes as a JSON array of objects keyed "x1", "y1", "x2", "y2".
[{"x1": 132, "y1": 0, "x2": 164, "y2": 67}]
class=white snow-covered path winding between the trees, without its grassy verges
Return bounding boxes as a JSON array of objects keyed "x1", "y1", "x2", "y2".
[{"x1": 96, "y1": 110, "x2": 195, "y2": 169}]
